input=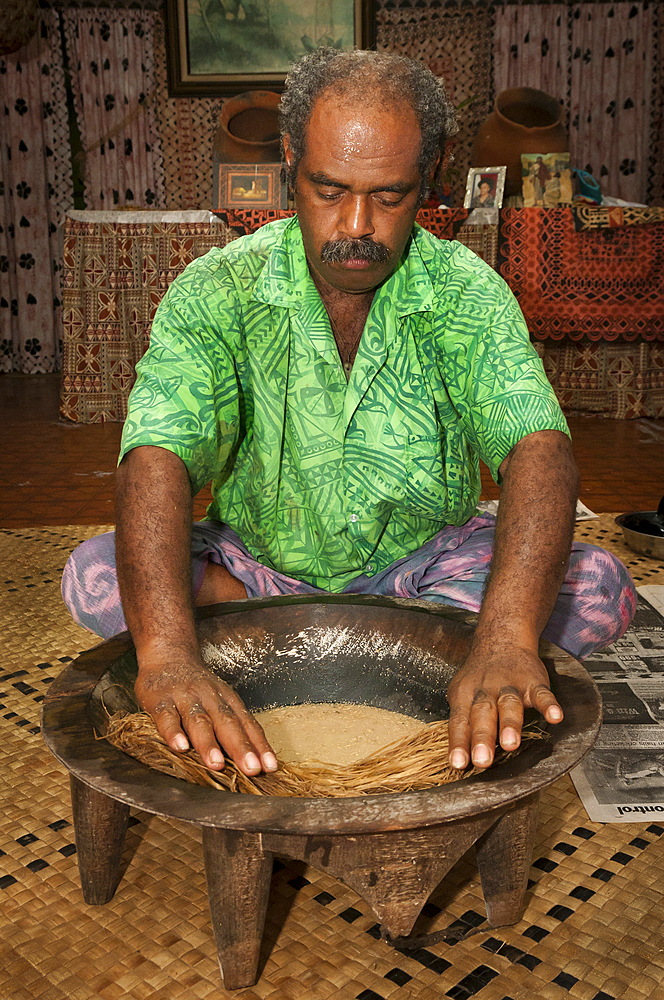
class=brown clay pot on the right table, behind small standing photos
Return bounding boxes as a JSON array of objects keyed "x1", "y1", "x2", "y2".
[{"x1": 470, "y1": 87, "x2": 569, "y2": 197}]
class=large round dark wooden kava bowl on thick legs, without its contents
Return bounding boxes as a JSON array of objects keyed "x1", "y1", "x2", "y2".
[{"x1": 43, "y1": 595, "x2": 601, "y2": 989}]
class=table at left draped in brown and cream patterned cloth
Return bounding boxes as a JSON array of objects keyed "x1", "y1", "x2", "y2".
[{"x1": 60, "y1": 212, "x2": 234, "y2": 423}]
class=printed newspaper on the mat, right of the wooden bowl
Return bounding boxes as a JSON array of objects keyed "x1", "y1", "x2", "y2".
[{"x1": 572, "y1": 587, "x2": 664, "y2": 823}]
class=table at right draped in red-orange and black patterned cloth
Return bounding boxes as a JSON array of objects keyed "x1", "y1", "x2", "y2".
[{"x1": 498, "y1": 207, "x2": 664, "y2": 418}]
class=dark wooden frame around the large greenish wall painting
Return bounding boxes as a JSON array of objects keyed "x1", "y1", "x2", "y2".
[{"x1": 166, "y1": 0, "x2": 376, "y2": 97}]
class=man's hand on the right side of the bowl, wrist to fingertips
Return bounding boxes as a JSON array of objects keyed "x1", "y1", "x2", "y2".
[{"x1": 447, "y1": 647, "x2": 563, "y2": 770}]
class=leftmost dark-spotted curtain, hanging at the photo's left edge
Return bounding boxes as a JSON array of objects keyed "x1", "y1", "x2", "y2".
[{"x1": 0, "y1": 10, "x2": 73, "y2": 373}]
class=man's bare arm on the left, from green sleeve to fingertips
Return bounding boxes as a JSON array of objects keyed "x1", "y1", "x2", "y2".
[{"x1": 116, "y1": 447, "x2": 276, "y2": 774}]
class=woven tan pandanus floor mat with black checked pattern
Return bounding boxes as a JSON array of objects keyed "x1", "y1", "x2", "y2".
[{"x1": 0, "y1": 514, "x2": 664, "y2": 1000}]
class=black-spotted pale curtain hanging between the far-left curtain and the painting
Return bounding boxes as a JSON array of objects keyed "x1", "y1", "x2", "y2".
[{"x1": 62, "y1": 9, "x2": 164, "y2": 209}]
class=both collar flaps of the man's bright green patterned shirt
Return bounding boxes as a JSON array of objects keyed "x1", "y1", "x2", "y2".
[{"x1": 254, "y1": 216, "x2": 433, "y2": 316}]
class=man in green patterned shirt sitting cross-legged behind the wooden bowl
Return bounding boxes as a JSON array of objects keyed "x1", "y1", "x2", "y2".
[{"x1": 63, "y1": 49, "x2": 635, "y2": 774}]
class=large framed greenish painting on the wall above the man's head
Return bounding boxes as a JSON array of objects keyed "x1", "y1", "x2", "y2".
[{"x1": 166, "y1": 0, "x2": 376, "y2": 97}]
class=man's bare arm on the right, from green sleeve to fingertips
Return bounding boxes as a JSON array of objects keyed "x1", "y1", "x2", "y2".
[{"x1": 448, "y1": 431, "x2": 578, "y2": 768}]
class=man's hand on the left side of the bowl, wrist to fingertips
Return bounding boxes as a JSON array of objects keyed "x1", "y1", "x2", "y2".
[{"x1": 134, "y1": 659, "x2": 277, "y2": 776}]
